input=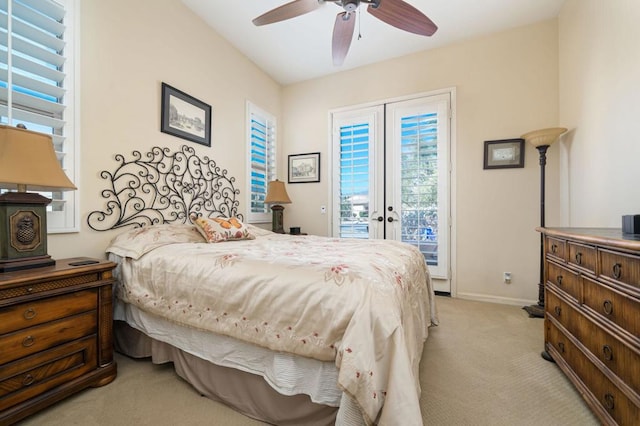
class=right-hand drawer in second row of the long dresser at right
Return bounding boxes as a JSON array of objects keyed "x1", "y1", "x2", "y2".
[{"x1": 582, "y1": 277, "x2": 640, "y2": 338}]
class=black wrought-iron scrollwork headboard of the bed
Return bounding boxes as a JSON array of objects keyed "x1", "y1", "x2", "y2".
[{"x1": 87, "y1": 145, "x2": 242, "y2": 231}]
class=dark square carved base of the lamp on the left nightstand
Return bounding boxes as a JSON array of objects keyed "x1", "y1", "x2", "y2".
[{"x1": 0, "y1": 192, "x2": 55, "y2": 272}]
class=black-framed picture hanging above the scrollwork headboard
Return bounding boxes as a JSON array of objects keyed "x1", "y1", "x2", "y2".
[{"x1": 160, "y1": 83, "x2": 211, "y2": 146}]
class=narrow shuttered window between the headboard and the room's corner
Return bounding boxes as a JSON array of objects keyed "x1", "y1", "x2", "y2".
[{"x1": 247, "y1": 102, "x2": 276, "y2": 223}]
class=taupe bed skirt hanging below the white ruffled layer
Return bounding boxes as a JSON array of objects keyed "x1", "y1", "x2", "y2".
[{"x1": 114, "y1": 321, "x2": 341, "y2": 426}]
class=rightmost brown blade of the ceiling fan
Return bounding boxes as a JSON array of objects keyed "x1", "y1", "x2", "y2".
[{"x1": 367, "y1": 0, "x2": 438, "y2": 36}]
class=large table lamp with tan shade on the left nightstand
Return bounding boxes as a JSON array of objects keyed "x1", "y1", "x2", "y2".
[{"x1": 0, "y1": 125, "x2": 77, "y2": 272}]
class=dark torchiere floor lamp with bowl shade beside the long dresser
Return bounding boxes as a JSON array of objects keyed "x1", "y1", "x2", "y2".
[{"x1": 522, "y1": 127, "x2": 567, "y2": 318}]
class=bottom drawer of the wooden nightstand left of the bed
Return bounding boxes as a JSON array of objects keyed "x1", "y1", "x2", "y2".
[{"x1": 0, "y1": 335, "x2": 97, "y2": 411}]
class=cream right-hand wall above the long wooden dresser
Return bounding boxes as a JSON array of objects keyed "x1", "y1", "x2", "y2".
[{"x1": 559, "y1": 0, "x2": 640, "y2": 228}]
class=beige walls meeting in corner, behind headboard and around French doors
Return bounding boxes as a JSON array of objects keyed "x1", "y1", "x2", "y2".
[{"x1": 49, "y1": 0, "x2": 559, "y2": 303}]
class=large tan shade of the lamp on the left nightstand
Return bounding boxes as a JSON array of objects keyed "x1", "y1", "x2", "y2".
[{"x1": 0, "y1": 125, "x2": 77, "y2": 191}]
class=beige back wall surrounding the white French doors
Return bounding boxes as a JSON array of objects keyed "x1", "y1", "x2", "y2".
[{"x1": 281, "y1": 20, "x2": 558, "y2": 304}]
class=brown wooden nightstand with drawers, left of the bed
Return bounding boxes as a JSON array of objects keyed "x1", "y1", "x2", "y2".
[{"x1": 0, "y1": 258, "x2": 116, "y2": 425}]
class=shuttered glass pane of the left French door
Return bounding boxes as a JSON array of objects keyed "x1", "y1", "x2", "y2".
[{"x1": 339, "y1": 123, "x2": 370, "y2": 239}]
